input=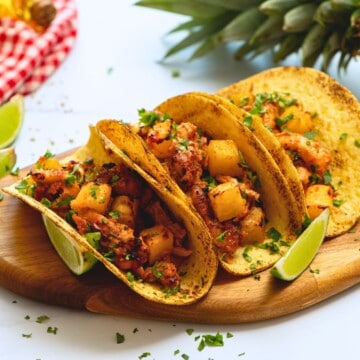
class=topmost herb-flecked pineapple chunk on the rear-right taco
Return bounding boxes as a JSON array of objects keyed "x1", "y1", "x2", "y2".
[{"x1": 280, "y1": 106, "x2": 314, "y2": 134}]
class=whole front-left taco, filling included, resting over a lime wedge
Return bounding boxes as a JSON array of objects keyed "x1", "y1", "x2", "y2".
[{"x1": 3, "y1": 126, "x2": 218, "y2": 305}]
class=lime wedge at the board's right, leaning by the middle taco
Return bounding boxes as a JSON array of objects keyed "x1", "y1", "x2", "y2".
[{"x1": 270, "y1": 209, "x2": 330, "y2": 281}]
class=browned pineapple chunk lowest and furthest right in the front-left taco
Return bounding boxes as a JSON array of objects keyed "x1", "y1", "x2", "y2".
[{"x1": 140, "y1": 225, "x2": 174, "y2": 264}]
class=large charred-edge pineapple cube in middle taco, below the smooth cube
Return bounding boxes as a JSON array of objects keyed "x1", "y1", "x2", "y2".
[{"x1": 209, "y1": 181, "x2": 247, "y2": 222}]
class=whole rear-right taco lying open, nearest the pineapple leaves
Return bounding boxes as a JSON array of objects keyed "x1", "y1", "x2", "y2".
[{"x1": 217, "y1": 67, "x2": 360, "y2": 237}]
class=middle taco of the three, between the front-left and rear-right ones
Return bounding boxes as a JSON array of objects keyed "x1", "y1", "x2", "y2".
[{"x1": 97, "y1": 93, "x2": 305, "y2": 276}]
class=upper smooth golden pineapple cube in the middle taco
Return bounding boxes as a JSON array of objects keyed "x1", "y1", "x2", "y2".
[{"x1": 207, "y1": 140, "x2": 243, "y2": 177}]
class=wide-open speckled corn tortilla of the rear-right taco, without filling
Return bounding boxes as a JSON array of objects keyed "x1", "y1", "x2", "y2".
[{"x1": 217, "y1": 67, "x2": 360, "y2": 237}]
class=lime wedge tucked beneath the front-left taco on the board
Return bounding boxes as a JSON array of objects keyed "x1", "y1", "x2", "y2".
[{"x1": 42, "y1": 215, "x2": 97, "y2": 275}]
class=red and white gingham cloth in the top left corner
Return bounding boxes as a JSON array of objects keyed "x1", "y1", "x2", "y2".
[{"x1": 0, "y1": 0, "x2": 77, "y2": 104}]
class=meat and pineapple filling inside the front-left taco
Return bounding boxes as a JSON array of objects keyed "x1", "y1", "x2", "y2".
[{"x1": 18, "y1": 154, "x2": 191, "y2": 291}]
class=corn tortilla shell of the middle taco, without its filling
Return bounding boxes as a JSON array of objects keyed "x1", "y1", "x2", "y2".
[{"x1": 97, "y1": 93, "x2": 304, "y2": 276}]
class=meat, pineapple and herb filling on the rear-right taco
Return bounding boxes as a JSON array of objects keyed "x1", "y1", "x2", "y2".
[{"x1": 238, "y1": 92, "x2": 334, "y2": 220}]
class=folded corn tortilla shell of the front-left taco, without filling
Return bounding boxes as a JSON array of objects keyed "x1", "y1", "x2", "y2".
[{"x1": 3, "y1": 126, "x2": 217, "y2": 305}]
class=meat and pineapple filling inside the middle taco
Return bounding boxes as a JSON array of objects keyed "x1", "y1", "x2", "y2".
[{"x1": 138, "y1": 110, "x2": 265, "y2": 262}]
